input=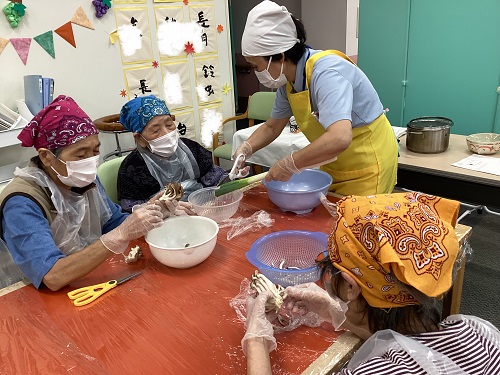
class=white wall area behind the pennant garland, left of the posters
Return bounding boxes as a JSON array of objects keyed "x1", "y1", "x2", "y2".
[{"x1": 0, "y1": 0, "x2": 126, "y2": 122}]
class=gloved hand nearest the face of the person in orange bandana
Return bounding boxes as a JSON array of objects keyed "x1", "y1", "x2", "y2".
[{"x1": 284, "y1": 283, "x2": 348, "y2": 330}]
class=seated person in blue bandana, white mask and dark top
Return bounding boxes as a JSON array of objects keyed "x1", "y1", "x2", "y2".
[{"x1": 118, "y1": 95, "x2": 227, "y2": 211}]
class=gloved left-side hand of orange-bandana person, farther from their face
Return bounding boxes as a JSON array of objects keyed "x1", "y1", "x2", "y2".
[{"x1": 241, "y1": 292, "x2": 276, "y2": 355}]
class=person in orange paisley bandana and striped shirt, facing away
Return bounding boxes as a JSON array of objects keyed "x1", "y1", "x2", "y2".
[{"x1": 242, "y1": 193, "x2": 500, "y2": 375}]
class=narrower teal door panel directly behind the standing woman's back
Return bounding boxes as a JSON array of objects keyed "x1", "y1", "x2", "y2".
[{"x1": 358, "y1": 0, "x2": 410, "y2": 126}]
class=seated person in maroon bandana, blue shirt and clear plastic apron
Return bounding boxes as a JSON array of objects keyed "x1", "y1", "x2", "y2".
[{"x1": 0, "y1": 95, "x2": 169, "y2": 291}]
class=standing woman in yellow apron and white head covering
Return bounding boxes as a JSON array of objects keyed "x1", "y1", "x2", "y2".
[{"x1": 235, "y1": 1, "x2": 398, "y2": 195}]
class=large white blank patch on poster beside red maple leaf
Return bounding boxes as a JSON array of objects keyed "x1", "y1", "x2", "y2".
[{"x1": 158, "y1": 22, "x2": 205, "y2": 56}]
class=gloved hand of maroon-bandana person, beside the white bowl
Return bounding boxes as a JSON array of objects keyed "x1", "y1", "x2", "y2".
[{"x1": 101, "y1": 204, "x2": 163, "y2": 254}]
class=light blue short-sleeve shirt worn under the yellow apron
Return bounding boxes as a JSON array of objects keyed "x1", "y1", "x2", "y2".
[{"x1": 271, "y1": 49, "x2": 383, "y2": 129}]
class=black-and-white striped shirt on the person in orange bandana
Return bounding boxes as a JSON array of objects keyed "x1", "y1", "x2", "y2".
[{"x1": 339, "y1": 315, "x2": 500, "y2": 375}]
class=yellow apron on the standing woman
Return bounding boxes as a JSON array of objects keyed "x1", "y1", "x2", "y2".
[{"x1": 287, "y1": 50, "x2": 398, "y2": 195}]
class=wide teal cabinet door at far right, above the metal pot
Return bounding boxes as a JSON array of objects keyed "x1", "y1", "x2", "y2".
[{"x1": 404, "y1": 0, "x2": 500, "y2": 135}]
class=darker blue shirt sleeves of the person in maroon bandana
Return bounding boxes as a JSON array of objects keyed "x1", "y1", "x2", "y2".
[{"x1": 2, "y1": 182, "x2": 128, "y2": 289}]
